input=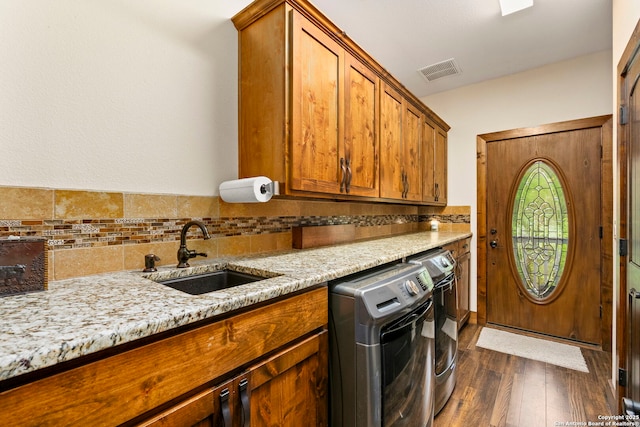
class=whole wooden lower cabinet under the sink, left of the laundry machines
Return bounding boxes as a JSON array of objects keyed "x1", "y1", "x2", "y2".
[{"x1": 0, "y1": 286, "x2": 328, "y2": 427}]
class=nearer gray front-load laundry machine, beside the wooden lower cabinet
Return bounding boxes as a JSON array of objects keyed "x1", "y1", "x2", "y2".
[{"x1": 329, "y1": 264, "x2": 435, "y2": 427}]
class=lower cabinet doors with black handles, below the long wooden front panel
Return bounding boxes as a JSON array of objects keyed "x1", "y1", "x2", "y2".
[{"x1": 137, "y1": 331, "x2": 328, "y2": 427}]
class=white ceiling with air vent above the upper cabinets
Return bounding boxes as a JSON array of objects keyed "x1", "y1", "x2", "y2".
[{"x1": 311, "y1": 0, "x2": 612, "y2": 97}]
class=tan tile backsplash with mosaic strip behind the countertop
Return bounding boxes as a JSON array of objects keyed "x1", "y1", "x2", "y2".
[{"x1": 0, "y1": 187, "x2": 470, "y2": 280}]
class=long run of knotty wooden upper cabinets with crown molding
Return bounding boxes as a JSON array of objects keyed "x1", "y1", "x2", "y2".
[{"x1": 233, "y1": 0, "x2": 448, "y2": 204}]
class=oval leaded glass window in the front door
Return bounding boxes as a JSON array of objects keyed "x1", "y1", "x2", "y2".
[{"x1": 511, "y1": 160, "x2": 569, "y2": 300}]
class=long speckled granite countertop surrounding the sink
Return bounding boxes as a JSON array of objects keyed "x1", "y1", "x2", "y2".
[{"x1": 0, "y1": 232, "x2": 471, "y2": 381}]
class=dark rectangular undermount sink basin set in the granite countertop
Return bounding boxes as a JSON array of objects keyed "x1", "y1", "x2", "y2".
[{"x1": 158, "y1": 270, "x2": 264, "y2": 295}]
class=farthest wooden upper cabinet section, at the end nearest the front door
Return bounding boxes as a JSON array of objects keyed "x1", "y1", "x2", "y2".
[{"x1": 422, "y1": 118, "x2": 447, "y2": 205}]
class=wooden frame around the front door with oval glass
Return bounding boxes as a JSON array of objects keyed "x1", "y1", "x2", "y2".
[{"x1": 476, "y1": 114, "x2": 614, "y2": 352}]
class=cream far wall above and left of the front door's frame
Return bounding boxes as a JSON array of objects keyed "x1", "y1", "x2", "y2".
[{"x1": 422, "y1": 51, "x2": 612, "y2": 311}]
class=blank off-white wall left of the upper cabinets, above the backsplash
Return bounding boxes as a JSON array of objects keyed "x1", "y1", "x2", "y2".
[{"x1": 0, "y1": 0, "x2": 255, "y2": 195}]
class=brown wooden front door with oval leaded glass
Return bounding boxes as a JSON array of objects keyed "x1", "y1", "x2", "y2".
[{"x1": 486, "y1": 121, "x2": 602, "y2": 344}]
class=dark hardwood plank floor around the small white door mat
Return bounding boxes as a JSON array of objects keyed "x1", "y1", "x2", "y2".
[{"x1": 434, "y1": 324, "x2": 617, "y2": 427}]
